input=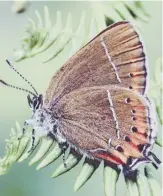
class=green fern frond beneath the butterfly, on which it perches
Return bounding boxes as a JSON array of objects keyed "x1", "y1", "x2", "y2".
[{"x1": 0, "y1": 122, "x2": 161, "y2": 196}]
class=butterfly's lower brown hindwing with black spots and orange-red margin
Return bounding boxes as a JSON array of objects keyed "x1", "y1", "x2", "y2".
[{"x1": 53, "y1": 86, "x2": 154, "y2": 163}]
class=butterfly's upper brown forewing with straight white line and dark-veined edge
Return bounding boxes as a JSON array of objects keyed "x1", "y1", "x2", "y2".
[{"x1": 45, "y1": 21, "x2": 146, "y2": 105}]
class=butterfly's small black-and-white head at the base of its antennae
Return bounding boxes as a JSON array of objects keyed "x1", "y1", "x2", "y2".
[{"x1": 27, "y1": 94, "x2": 43, "y2": 112}]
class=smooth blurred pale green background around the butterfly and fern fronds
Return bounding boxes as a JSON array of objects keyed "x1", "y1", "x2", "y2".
[{"x1": 0, "y1": 1, "x2": 162, "y2": 196}]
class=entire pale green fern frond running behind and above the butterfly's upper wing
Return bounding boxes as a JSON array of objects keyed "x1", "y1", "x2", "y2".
[{"x1": 14, "y1": 1, "x2": 148, "y2": 62}]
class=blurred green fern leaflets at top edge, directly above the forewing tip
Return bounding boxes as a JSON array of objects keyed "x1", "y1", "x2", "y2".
[{"x1": 93, "y1": 1, "x2": 149, "y2": 26}]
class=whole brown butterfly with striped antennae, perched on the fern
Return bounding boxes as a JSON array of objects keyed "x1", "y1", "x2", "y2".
[{"x1": 0, "y1": 21, "x2": 159, "y2": 174}]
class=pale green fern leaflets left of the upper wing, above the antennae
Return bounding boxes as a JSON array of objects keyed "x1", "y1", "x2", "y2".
[{"x1": 14, "y1": 6, "x2": 101, "y2": 62}]
